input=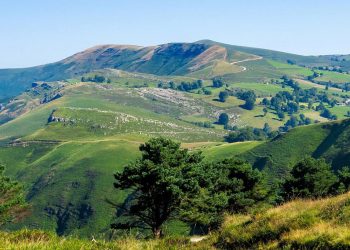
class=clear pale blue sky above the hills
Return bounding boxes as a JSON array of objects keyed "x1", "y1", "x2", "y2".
[{"x1": 0, "y1": 0, "x2": 350, "y2": 68}]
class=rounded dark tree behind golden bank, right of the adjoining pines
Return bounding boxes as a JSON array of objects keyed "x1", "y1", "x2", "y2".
[{"x1": 283, "y1": 157, "x2": 337, "y2": 200}]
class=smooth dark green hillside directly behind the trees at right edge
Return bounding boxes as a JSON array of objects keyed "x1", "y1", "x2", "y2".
[{"x1": 241, "y1": 120, "x2": 350, "y2": 178}]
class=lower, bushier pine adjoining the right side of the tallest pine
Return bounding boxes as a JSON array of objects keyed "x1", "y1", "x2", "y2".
[{"x1": 182, "y1": 158, "x2": 267, "y2": 230}]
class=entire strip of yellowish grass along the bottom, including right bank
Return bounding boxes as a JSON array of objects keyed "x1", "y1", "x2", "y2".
[{"x1": 0, "y1": 193, "x2": 350, "y2": 250}]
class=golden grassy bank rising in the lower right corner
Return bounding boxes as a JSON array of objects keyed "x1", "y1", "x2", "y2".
[{"x1": 217, "y1": 193, "x2": 350, "y2": 249}]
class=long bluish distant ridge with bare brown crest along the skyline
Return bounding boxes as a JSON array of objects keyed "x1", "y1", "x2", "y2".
[{"x1": 0, "y1": 40, "x2": 349, "y2": 98}]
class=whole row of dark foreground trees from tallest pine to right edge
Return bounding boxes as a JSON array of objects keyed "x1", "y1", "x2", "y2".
[{"x1": 112, "y1": 138, "x2": 350, "y2": 238}]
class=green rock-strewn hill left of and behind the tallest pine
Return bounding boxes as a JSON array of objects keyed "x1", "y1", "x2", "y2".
[{"x1": 0, "y1": 83, "x2": 230, "y2": 236}]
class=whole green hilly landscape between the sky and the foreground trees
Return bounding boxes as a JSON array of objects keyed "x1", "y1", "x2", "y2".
[{"x1": 0, "y1": 41, "x2": 350, "y2": 244}]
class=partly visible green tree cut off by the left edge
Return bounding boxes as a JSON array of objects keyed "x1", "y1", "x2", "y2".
[{"x1": 0, "y1": 164, "x2": 27, "y2": 226}]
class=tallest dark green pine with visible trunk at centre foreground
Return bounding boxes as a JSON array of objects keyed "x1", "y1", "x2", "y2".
[{"x1": 112, "y1": 138, "x2": 202, "y2": 238}]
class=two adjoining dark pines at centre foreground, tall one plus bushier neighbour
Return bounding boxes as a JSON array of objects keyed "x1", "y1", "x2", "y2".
[{"x1": 112, "y1": 138, "x2": 268, "y2": 238}]
